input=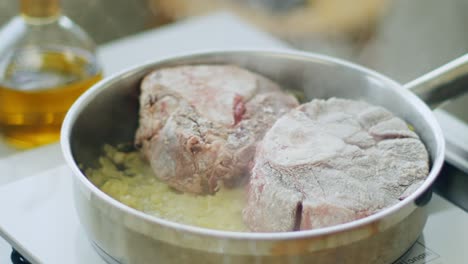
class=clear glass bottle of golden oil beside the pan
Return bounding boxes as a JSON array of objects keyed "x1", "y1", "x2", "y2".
[{"x1": 0, "y1": 0, "x2": 101, "y2": 148}]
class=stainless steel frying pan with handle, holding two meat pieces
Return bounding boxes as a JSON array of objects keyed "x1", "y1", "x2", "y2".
[{"x1": 61, "y1": 50, "x2": 468, "y2": 263}]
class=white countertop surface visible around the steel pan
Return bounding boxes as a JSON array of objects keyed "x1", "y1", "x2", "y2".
[{"x1": 0, "y1": 10, "x2": 468, "y2": 264}]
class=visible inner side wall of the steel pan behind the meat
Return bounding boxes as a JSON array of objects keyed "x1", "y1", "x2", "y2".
[{"x1": 69, "y1": 51, "x2": 443, "y2": 236}]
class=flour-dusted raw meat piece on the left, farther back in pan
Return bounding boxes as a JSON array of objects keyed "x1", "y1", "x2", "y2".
[{"x1": 135, "y1": 65, "x2": 298, "y2": 194}]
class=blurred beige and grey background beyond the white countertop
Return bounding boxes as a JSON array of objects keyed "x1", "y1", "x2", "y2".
[{"x1": 0, "y1": 0, "x2": 468, "y2": 117}]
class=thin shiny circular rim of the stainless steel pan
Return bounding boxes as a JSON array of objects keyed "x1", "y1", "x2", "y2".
[{"x1": 60, "y1": 48, "x2": 445, "y2": 240}]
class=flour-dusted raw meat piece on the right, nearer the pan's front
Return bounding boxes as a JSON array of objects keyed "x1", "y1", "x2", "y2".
[{"x1": 243, "y1": 98, "x2": 429, "y2": 232}]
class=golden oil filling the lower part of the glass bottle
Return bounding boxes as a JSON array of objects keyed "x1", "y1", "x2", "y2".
[{"x1": 0, "y1": 47, "x2": 101, "y2": 148}]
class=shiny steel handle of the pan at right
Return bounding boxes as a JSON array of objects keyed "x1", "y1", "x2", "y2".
[{"x1": 403, "y1": 54, "x2": 468, "y2": 109}]
